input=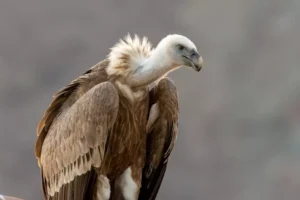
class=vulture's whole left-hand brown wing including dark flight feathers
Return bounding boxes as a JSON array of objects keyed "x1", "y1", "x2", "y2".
[{"x1": 35, "y1": 59, "x2": 119, "y2": 200}]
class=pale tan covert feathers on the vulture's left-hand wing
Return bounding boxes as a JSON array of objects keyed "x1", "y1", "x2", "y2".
[{"x1": 41, "y1": 82, "x2": 119, "y2": 196}]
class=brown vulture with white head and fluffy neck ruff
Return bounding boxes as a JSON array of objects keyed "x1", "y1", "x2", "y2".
[{"x1": 35, "y1": 34, "x2": 203, "y2": 200}]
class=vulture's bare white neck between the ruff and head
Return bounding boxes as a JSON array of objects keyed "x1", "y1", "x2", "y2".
[{"x1": 129, "y1": 49, "x2": 179, "y2": 87}]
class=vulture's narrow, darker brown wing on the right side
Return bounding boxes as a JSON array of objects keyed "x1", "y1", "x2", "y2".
[{"x1": 139, "y1": 78, "x2": 178, "y2": 200}]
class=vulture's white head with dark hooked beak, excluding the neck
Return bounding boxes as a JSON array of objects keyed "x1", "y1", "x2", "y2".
[{"x1": 155, "y1": 34, "x2": 203, "y2": 71}]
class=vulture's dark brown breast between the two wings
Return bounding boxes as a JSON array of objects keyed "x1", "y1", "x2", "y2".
[{"x1": 104, "y1": 88, "x2": 149, "y2": 179}]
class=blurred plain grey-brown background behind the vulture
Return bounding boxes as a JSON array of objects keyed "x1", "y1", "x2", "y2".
[{"x1": 0, "y1": 0, "x2": 300, "y2": 200}]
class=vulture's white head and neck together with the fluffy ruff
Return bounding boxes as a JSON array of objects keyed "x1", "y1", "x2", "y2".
[{"x1": 106, "y1": 34, "x2": 203, "y2": 87}]
